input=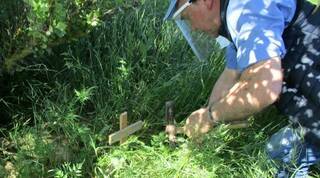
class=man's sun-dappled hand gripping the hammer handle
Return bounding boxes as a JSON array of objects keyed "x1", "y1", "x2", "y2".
[{"x1": 184, "y1": 108, "x2": 213, "y2": 138}]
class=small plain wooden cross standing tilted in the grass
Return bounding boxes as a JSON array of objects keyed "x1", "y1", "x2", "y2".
[{"x1": 109, "y1": 112, "x2": 143, "y2": 145}]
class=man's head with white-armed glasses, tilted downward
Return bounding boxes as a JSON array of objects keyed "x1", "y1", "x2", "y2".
[{"x1": 165, "y1": 0, "x2": 221, "y2": 37}]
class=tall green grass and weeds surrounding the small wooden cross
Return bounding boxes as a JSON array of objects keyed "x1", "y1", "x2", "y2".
[{"x1": 0, "y1": 0, "x2": 320, "y2": 178}]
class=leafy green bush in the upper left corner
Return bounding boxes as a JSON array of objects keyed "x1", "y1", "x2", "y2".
[{"x1": 0, "y1": 0, "x2": 123, "y2": 72}]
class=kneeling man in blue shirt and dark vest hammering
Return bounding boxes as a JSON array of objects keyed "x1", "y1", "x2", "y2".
[{"x1": 165, "y1": 0, "x2": 320, "y2": 177}]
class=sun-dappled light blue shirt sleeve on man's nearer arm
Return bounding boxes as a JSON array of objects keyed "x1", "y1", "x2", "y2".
[{"x1": 228, "y1": 0, "x2": 296, "y2": 71}]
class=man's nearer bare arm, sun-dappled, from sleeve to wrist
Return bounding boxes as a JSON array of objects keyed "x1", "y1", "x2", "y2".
[{"x1": 209, "y1": 57, "x2": 283, "y2": 121}]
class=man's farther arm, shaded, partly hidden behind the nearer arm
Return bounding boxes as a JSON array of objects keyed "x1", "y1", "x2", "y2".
[{"x1": 209, "y1": 68, "x2": 240, "y2": 106}]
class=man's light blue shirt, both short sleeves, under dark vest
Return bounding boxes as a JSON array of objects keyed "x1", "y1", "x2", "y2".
[{"x1": 226, "y1": 0, "x2": 296, "y2": 71}]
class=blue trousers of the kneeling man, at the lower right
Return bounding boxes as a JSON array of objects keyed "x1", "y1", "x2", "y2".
[{"x1": 266, "y1": 126, "x2": 320, "y2": 178}]
